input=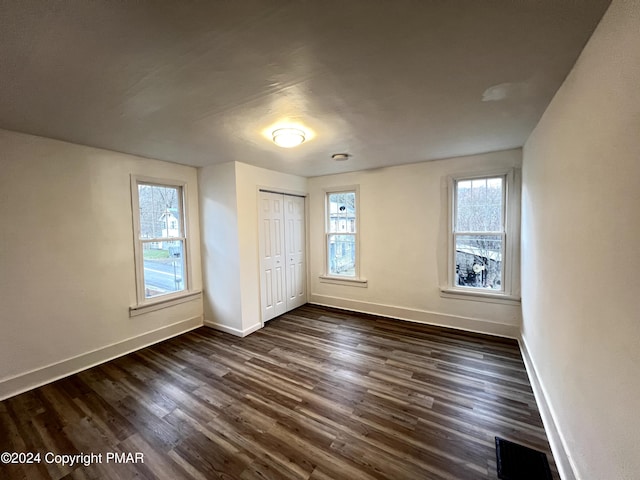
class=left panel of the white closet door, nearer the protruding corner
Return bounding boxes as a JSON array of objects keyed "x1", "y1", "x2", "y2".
[{"x1": 258, "y1": 192, "x2": 287, "y2": 322}]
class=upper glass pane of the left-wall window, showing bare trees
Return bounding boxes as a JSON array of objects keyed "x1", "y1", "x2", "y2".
[{"x1": 138, "y1": 184, "x2": 182, "y2": 238}]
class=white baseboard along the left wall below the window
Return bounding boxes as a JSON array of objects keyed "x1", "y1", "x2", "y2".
[{"x1": 0, "y1": 316, "x2": 202, "y2": 400}]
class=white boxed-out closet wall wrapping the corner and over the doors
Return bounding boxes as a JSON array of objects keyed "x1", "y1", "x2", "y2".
[{"x1": 199, "y1": 162, "x2": 307, "y2": 336}]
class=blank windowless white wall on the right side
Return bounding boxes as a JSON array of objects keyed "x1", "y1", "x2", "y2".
[{"x1": 522, "y1": 0, "x2": 640, "y2": 480}]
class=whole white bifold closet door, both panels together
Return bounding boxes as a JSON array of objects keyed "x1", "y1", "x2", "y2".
[{"x1": 258, "y1": 191, "x2": 307, "y2": 322}]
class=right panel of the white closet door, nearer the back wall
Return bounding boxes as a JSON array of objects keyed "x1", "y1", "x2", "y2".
[{"x1": 284, "y1": 195, "x2": 307, "y2": 311}]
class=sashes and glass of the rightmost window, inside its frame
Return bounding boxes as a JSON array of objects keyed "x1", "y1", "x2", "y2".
[{"x1": 452, "y1": 175, "x2": 507, "y2": 293}]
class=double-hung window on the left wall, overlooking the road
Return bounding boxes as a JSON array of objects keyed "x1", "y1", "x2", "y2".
[{"x1": 132, "y1": 178, "x2": 189, "y2": 304}]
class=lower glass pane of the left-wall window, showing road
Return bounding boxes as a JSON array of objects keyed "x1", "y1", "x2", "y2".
[{"x1": 142, "y1": 240, "x2": 185, "y2": 298}]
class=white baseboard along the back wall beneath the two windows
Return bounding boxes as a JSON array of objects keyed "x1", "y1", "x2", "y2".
[{"x1": 309, "y1": 293, "x2": 520, "y2": 339}]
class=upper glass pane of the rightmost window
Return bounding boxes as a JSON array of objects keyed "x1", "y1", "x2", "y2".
[{"x1": 455, "y1": 177, "x2": 503, "y2": 232}]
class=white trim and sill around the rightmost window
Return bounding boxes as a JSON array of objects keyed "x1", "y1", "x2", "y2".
[{"x1": 440, "y1": 168, "x2": 521, "y2": 305}]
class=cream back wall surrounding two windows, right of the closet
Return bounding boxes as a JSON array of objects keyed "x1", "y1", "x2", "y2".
[{"x1": 308, "y1": 149, "x2": 521, "y2": 338}]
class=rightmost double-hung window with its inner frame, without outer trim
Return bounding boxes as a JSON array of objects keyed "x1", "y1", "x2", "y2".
[{"x1": 449, "y1": 172, "x2": 517, "y2": 297}]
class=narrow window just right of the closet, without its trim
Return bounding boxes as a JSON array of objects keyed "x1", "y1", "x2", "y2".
[{"x1": 326, "y1": 190, "x2": 358, "y2": 279}]
